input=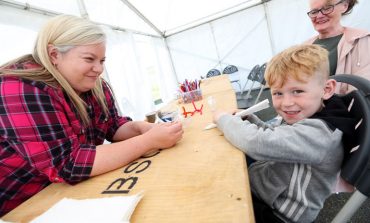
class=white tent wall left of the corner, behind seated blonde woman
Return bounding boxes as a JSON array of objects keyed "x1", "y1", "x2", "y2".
[{"x1": 0, "y1": 5, "x2": 177, "y2": 120}]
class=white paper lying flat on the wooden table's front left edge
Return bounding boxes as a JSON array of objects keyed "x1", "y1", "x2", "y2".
[{"x1": 31, "y1": 194, "x2": 142, "y2": 223}]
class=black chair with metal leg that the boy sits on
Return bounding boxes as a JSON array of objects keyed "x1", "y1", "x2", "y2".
[{"x1": 332, "y1": 74, "x2": 370, "y2": 222}]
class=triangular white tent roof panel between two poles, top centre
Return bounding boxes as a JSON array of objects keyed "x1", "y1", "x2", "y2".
[{"x1": 130, "y1": 0, "x2": 261, "y2": 35}]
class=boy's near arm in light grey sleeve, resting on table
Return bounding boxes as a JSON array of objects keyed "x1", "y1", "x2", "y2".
[{"x1": 217, "y1": 115, "x2": 342, "y2": 164}]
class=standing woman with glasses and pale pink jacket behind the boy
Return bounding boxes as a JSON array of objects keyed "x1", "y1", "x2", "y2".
[{"x1": 307, "y1": 0, "x2": 370, "y2": 93}]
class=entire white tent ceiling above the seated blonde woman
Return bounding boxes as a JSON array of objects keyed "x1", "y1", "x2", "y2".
[{"x1": 0, "y1": 0, "x2": 264, "y2": 37}]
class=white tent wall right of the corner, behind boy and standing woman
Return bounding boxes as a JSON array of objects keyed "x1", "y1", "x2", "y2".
[{"x1": 166, "y1": 0, "x2": 370, "y2": 90}]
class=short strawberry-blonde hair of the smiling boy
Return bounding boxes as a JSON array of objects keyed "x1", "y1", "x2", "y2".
[{"x1": 265, "y1": 44, "x2": 329, "y2": 87}]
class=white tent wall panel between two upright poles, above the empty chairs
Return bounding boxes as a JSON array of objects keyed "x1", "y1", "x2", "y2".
[{"x1": 166, "y1": 5, "x2": 272, "y2": 86}]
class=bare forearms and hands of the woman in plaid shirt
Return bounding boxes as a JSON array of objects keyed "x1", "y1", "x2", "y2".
[{"x1": 91, "y1": 122, "x2": 184, "y2": 176}]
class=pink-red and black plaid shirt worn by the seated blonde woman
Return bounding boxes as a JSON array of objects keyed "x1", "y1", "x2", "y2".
[{"x1": 0, "y1": 61, "x2": 130, "y2": 216}]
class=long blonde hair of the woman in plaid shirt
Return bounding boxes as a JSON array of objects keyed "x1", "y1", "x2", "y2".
[{"x1": 0, "y1": 15, "x2": 108, "y2": 125}]
